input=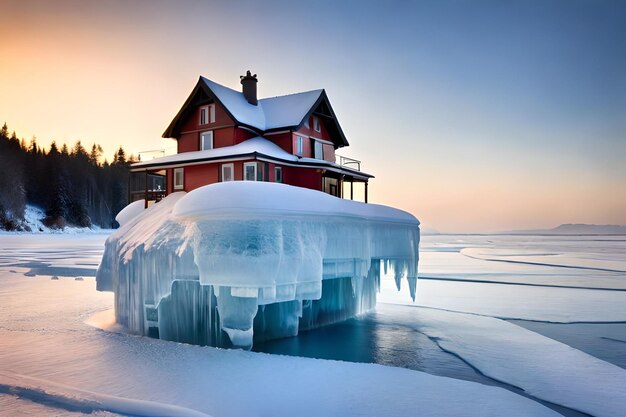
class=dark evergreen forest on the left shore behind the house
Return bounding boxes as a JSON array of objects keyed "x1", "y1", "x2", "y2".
[{"x1": 0, "y1": 123, "x2": 135, "y2": 230}]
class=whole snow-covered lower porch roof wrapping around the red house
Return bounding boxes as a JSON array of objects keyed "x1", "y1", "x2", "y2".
[{"x1": 131, "y1": 136, "x2": 373, "y2": 178}]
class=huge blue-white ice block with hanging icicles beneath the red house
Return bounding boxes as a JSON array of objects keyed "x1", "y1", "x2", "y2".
[{"x1": 97, "y1": 181, "x2": 420, "y2": 348}]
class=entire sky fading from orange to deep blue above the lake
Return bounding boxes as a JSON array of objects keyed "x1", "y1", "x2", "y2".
[{"x1": 0, "y1": 0, "x2": 626, "y2": 232}]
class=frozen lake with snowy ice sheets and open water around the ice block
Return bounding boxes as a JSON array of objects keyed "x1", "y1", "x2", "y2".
[{"x1": 0, "y1": 234, "x2": 626, "y2": 416}]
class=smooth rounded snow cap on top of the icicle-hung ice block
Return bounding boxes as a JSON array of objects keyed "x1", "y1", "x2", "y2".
[{"x1": 172, "y1": 181, "x2": 420, "y2": 226}]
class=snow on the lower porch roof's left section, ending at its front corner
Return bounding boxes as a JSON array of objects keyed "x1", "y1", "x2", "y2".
[{"x1": 132, "y1": 136, "x2": 298, "y2": 168}]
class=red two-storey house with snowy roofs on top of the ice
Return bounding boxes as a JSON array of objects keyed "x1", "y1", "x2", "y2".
[{"x1": 129, "y1": 71, "x2": 373, "y2": 204}]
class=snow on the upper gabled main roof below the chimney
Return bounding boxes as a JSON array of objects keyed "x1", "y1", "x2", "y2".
[{"x1": 201, "y1": 77, "x2": 323, "y2": 130}]
